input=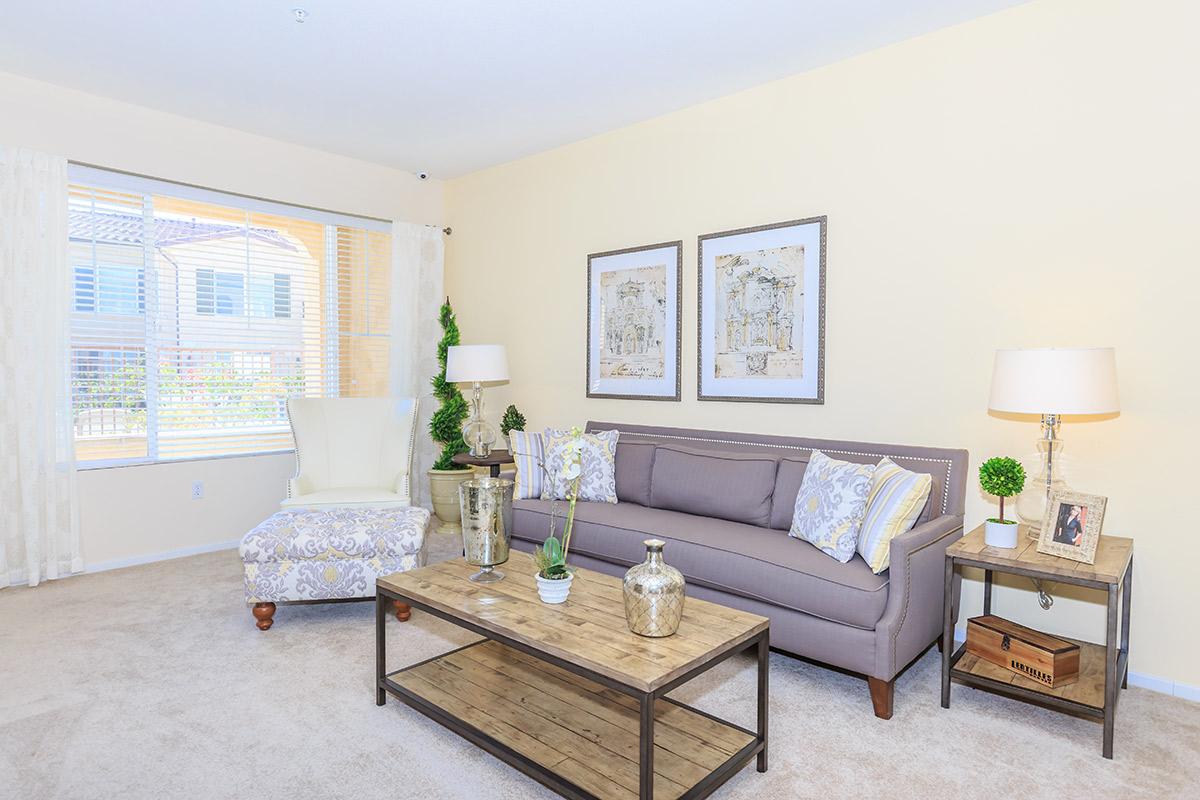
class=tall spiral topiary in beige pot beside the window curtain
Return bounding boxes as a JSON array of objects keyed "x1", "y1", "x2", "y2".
[{"x1": 428, "y1": 297, "x2": 474, "y2": 534}]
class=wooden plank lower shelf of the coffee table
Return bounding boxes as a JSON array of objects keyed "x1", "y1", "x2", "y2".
[{"x1": 382, "y1": 640, "x2": 761, "y2": 800}]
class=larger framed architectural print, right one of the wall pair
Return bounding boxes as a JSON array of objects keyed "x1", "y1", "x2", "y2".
[{"x1": 696, "y1": 217, "x2": 826, "y2": 403}]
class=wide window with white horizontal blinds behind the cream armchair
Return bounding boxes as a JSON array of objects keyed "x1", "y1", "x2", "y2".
[{"x1": 68, "y1": 167, "x2": 391, "y2": 464}]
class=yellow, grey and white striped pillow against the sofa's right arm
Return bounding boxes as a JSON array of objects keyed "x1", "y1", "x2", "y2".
[{"x1": 858, "y1": 458, "x2": 934, "y2": 575}]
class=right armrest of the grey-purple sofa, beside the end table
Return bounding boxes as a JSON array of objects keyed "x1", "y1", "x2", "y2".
[{"x1": 875, "y1": 515, "x2": 962, "y2": 680}]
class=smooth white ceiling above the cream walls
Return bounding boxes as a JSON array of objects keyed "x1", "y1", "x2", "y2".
[{"x1": 0, "y1": 0, "x2": 1021, "y2": 178}]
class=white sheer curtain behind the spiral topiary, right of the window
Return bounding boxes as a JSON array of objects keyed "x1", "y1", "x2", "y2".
[{"x1": 391, "y1": 222, "x2": 444, "y2": 507}]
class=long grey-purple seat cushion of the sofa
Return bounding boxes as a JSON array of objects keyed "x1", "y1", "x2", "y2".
[{"x1": 512, "y1": 496, "x2": 888, "y2": 630}]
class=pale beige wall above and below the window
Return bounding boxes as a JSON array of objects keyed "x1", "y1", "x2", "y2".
[{"x1": 0, "y1": 73, "x2": 443, "y2": 565}]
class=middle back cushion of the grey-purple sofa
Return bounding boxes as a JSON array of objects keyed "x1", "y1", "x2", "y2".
[{"x1": 650, "y1": 445, "x2": 778, "y2": 525}]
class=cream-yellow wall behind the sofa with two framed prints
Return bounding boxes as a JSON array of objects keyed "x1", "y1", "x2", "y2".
[{"x1": 446, "y1": 0, "x2": 1200, "y2": 686}]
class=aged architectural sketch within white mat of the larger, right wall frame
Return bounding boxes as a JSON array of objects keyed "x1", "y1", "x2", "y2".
[{"x1": 713, "y1": 245, "x2": 804, "y2": 378}]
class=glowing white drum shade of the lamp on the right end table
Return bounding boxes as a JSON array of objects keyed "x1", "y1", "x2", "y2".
[{"x1": 988, "y1": 348, "x2": 1121, "y2": 414}]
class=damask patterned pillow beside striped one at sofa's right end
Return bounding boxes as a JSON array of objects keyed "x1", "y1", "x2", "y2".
[{"x1": 787, "y1": 450, "x2": 875, "y2": 564}]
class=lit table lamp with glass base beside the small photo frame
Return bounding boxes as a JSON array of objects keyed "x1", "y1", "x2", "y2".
[{"x1": 988, "y1": 348, "x2": 1121, "y2": 539}]
